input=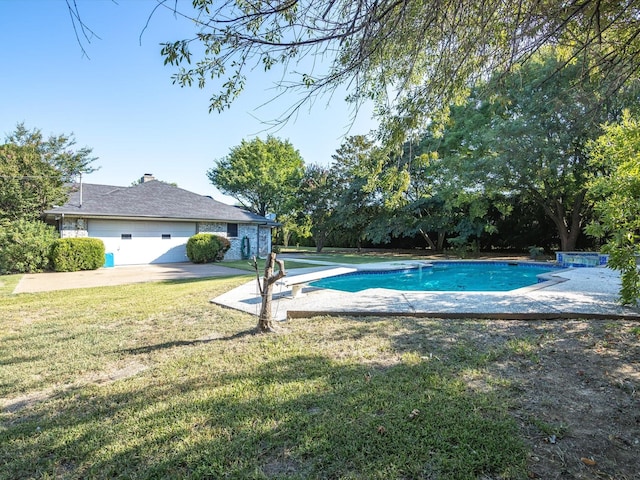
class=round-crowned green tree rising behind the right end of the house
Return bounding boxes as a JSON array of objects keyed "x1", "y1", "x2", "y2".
[{"x1": 207, "y1": 136, "x2": 304, "y2": 216}]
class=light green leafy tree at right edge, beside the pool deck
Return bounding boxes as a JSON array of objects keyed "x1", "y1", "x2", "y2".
[{"x1": 587, "y1": 111, "x2": 640, "y2": 305}]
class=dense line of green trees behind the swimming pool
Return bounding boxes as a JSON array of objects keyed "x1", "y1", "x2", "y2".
[{"x1": 209, "y1": 48, "x2": 640, "y2": 253}]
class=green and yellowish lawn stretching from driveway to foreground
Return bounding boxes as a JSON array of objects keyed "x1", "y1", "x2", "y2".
[{"x1": 0, "y1": 277, "x2": 527, "y2": 480}]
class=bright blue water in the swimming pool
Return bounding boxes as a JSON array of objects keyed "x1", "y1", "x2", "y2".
[{"x1": 310, "y1": 262, "x2": 557, "y2": 292}]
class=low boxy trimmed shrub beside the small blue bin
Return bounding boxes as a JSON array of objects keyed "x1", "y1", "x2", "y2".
[{"x1": 51, "y1": 238, "x2": 104, "y2": 272}]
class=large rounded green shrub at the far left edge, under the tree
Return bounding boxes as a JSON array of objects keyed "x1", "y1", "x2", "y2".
[{"x1": 0, "y1": 220, "x2": 58, "y2": 274}]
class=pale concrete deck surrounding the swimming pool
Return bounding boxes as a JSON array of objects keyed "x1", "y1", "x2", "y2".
[{"x1": 211, "y1": 260, "x2": 640, "y2": 320}]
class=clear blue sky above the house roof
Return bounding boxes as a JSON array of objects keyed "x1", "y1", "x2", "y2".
[{"x1": 0, "y1": 0, "x2": 375, "y2": 202}]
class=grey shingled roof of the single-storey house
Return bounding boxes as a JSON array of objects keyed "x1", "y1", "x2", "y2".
[{"x1": 45, "y1": 180, "x2": 273, "y2": 225}]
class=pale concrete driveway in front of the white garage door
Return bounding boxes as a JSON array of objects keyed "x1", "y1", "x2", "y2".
[{"x1": 13, "y1": 263, "x2": 249, "y2": 293}]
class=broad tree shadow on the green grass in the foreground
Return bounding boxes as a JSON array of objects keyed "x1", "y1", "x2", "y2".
[{"x1": 0, "y1": 342, "x2": 525, "y2": 479}]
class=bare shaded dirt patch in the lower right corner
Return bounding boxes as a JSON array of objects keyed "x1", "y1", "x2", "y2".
[{"x1": 474, "y1": 321, "x2": 640, "y2": 480}]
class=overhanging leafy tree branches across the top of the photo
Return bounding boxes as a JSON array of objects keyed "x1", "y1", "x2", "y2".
[{"x1": 155, "y1": 0, "x2": 640, "y2": 144}]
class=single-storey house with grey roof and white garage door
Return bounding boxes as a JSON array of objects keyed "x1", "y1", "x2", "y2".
[{"x1": 45, "y1": 174, "x2": 277, "y2": 265}]
